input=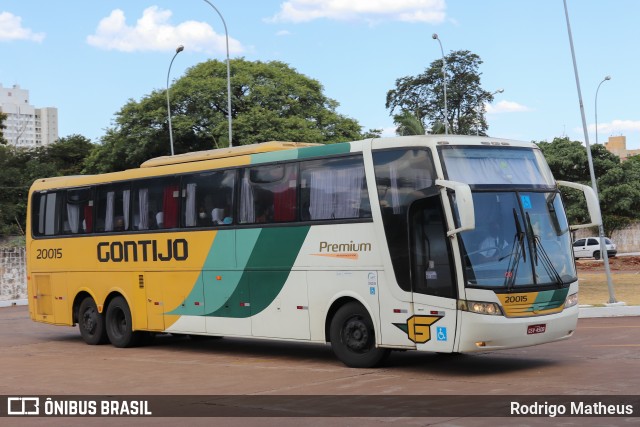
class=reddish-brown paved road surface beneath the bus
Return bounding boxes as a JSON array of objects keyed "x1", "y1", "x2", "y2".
[{"x1": 0, "y1": 306, "x2": 640, "y2": 426}]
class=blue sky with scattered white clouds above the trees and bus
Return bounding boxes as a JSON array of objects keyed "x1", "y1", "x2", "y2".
[{"x1": 0, "y1": 0, "x2": 640, "y2": 149}]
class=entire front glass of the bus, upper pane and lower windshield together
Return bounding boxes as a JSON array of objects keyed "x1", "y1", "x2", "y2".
[{"x1": 440, "y1": 147, "x2": 577, "y2": 289}]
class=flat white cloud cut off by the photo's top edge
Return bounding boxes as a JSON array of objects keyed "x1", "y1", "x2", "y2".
[{"x1": 269, "y1": 0, "x2": 446, "y2": 24}]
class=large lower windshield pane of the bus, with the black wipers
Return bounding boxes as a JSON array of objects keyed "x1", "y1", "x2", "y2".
[{"x1": 460, "y1": 192, "x2": 577, "y2": 289}]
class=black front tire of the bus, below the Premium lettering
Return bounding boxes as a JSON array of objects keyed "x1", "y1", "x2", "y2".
[{"x1": 329, "y1": 302, "x2": 390, "y2": 368}]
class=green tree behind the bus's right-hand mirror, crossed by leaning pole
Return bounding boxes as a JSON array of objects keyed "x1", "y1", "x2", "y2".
[{"x1": 538, "y1": 138, "x2": 640, "y2": 236}]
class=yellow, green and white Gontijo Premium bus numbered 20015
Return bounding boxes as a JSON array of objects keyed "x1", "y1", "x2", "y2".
[{"x1": 27, "y1": 135, "x2": 600, "y2": 367}]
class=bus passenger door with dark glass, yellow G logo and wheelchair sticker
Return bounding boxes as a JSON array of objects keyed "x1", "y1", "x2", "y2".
[{"x1": 407, "y1": 196, "x2": 457, "y2": 352}]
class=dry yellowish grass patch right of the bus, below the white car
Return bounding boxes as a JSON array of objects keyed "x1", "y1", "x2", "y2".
[{"x1": 578, "y1": 271, "x2": 640, "y2": 305}]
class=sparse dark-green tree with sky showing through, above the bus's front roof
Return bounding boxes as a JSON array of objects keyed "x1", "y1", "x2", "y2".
[{"x1": 386, "y1": 50, "x2": 493, "y2": 135}]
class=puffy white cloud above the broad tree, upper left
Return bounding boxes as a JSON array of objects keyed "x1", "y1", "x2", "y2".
[{"x1": 87, "y1": 6, "x2": 244, "y2": 54}]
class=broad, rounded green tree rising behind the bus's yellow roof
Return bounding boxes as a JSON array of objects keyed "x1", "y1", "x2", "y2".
[{"x1": 86, "y1": 59, "x2": 364, "y2": 172}]
